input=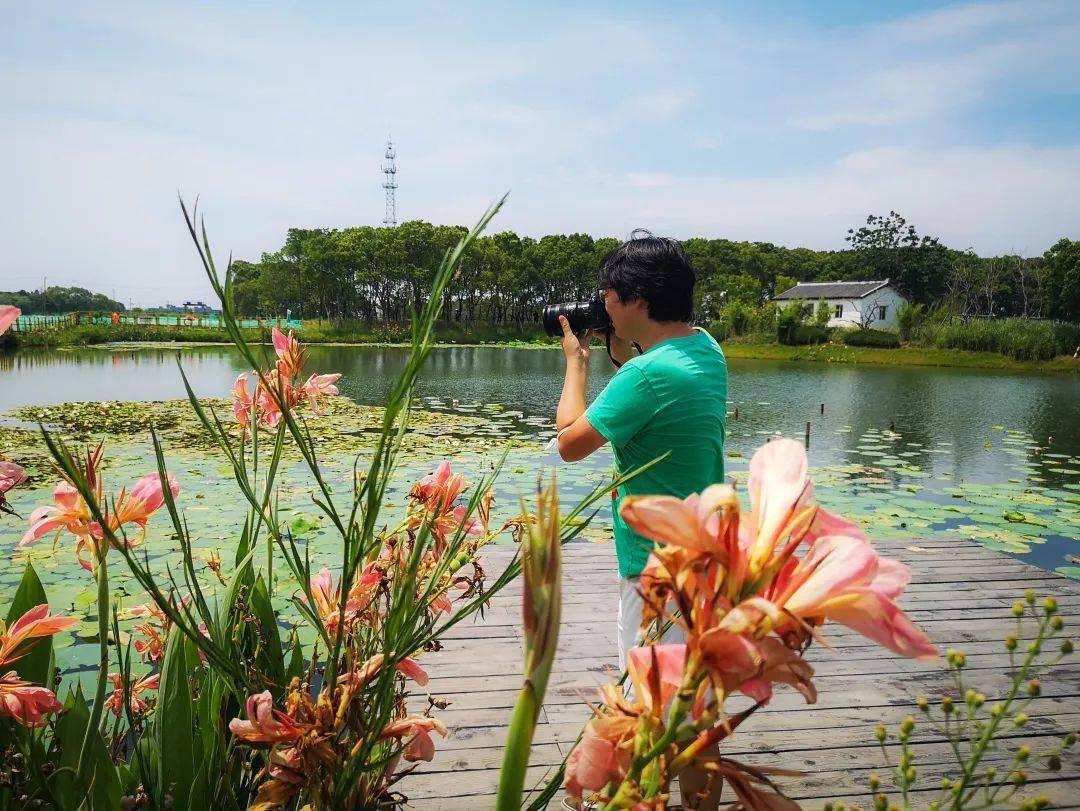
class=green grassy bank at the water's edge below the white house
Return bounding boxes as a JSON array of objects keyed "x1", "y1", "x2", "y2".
[{"x1": 724, "y1": 341, "x2": 1080, "y2": 375}]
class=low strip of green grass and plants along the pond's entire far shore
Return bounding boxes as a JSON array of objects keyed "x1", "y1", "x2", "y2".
[{"x1": 5, "y1": 322, "x2": 1080, "y2": 375}]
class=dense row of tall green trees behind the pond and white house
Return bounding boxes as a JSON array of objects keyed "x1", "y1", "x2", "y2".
[{"x1": 234, "y1": 212, "x2": 1080, "y2": 326}]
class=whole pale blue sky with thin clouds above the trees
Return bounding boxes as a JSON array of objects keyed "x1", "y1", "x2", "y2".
[{"x1": 0, "y1": 0, "x2": 1080, "y2": 303}]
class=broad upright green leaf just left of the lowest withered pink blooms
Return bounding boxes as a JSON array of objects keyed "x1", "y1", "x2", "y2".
[{"x1": 154, "y1": 628, "x2": 199, "y2": 808}]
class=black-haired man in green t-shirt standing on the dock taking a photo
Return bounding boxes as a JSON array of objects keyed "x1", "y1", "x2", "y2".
[{"x1": 555, "y1": 231, "x2": 728, "y2": 808}]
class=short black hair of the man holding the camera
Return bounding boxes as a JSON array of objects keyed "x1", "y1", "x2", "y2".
[{"x1": 599, "y1": 228, "x2": 694, "y2": 323}]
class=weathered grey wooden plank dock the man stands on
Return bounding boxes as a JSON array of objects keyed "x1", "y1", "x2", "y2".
[{"x1": 402, "y1": 539, "x2": 1080, "y2": 811}]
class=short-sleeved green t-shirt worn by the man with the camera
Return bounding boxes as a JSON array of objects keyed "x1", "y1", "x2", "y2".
[{"x1": 585, "y1": 329, "x2": 728, "y2": 578}]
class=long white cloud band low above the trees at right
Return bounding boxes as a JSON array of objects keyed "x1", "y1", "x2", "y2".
[{"x1": 505, "y1": 146, "x2": 1080, "y2": 255}]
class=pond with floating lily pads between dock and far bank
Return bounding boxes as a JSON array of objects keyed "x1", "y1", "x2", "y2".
[{"x1": 0, "y1": 346, "x2": 1080, "y2": 670}]
